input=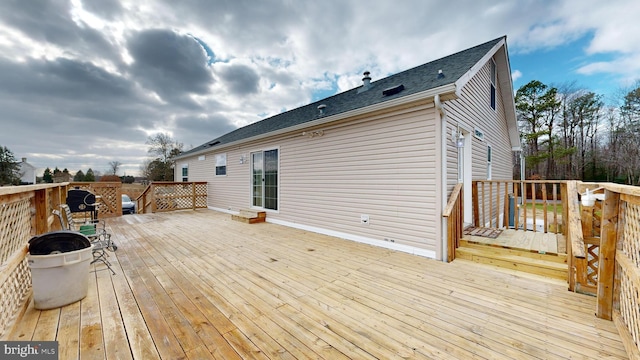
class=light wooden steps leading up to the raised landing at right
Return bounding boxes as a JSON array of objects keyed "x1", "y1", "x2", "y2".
[{"x1": 456, "y1": 240, "x2": 568, "y2": 280}]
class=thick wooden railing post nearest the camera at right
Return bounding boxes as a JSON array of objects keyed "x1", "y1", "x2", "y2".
[{"x1": 596, "y1": 190, "x2": 620, "y2": 320}]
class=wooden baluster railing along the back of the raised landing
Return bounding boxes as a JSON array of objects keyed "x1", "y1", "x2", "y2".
[{"x1": 472, "y1": 180, "x2": 566, "y2": 233}]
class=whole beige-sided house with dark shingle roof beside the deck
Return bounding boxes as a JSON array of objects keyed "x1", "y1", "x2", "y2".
[{"x1": 175, "y1": 37, "x2": 520, "y2": 259}]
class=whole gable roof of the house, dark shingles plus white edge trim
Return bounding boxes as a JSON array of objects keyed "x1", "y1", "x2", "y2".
[{"x1": 177, "y1": 36, "x2": 519, "y2": 159}]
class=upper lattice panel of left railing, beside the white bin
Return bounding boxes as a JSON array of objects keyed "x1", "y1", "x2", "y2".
[{"x1": 0, "y1": 196, "x2": 31, "y2": 269}]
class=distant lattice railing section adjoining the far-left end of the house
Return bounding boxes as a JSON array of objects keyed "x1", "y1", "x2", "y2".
[{"x1": 136, "y1": 182, "x2": 207, "y2": 214}]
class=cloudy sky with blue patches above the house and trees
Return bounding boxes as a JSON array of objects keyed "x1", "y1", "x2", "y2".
[{"x1": 0, "y1": 0, "x2": 640, "y2": 175}]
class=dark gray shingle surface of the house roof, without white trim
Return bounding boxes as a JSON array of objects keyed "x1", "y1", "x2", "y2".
[{"x1": 180, "y1": 37, "x2": 504, "y2": 157}]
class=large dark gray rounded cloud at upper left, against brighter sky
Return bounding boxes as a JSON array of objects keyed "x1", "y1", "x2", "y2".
[{"x1": 127, "y1": 29, "x2": 213, "y2": 98}]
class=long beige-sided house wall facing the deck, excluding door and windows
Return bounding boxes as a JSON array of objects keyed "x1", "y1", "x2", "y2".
[{"x1": 176, "y1": 102, "x2": 441, "y2": 257}]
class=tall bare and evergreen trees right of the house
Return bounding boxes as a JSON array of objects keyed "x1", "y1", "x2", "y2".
[{"x1": 514, "y1": 80, "x2": 640, "y2": 185}]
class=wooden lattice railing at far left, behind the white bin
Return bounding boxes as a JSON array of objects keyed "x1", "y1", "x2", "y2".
[{"x1": 0, "y1": 183, "x2": 69, "y2": 339}]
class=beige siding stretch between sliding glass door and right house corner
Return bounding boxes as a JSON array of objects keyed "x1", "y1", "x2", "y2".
[{"x1": 278, "y1": 107, "x2": 438, "y2": 251}]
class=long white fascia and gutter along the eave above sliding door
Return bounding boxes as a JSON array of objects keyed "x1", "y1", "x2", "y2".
[{"x1": 175, "y1": 84, "x2": 456, "y2": 160}]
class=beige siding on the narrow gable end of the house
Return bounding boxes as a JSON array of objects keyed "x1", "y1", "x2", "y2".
[{"x1": 444, "y1": 57, "x2": 513, "y2": 224}]
